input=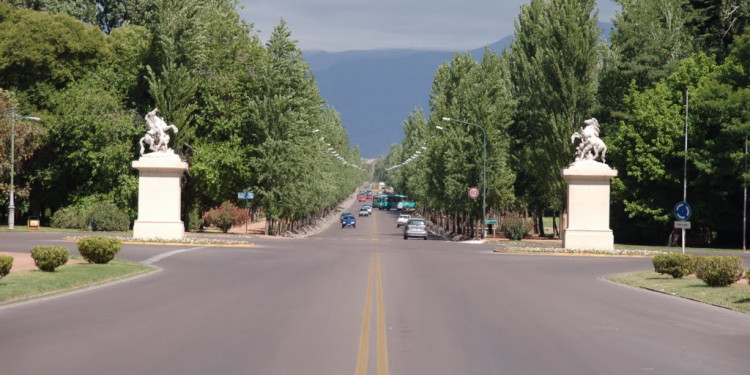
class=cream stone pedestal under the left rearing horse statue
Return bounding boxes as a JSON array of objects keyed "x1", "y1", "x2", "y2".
[{"x1": 133, "y1": 150, "x2": 188, "y2": 240}]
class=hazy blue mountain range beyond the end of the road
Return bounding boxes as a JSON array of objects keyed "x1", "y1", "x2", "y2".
[{"x1": 303, "y1": 23, "x2": 613, "y2": 158}]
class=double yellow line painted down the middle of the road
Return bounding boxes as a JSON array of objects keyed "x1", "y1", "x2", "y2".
[{"x1": 354, "y1": 253, "x2": 388, "y2": 375}]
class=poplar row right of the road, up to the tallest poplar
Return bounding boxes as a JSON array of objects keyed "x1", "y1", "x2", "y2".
[{"x1": 380, "y1": 50, "x2": 515, "y2": 236}]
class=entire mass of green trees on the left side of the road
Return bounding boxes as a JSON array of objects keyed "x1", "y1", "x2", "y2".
[{"x1": 0, "y1": 0, "x2": 364, "y2": 232}]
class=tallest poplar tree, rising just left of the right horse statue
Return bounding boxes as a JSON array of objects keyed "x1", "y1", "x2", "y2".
[{"x1": 509, "y1": 0, "x2": 606, "y2": 235}]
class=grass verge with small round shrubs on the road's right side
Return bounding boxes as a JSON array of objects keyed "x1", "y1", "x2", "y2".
[{"x1": 607, "y1": 271, "x2": 750, "y2": 313}]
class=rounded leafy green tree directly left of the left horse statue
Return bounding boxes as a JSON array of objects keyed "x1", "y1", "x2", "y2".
[{"x1": 34, "y1": 75, "x2": 141, "y2": 217}]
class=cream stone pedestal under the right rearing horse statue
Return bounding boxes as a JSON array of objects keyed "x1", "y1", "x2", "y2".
[{"x1": 562, "y1": 160, "x2": 617, "y2": 250}]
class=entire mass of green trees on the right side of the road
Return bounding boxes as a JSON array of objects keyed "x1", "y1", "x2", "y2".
[{"x1": 376, "y1": 0, "x2": 750, "y2": 245}]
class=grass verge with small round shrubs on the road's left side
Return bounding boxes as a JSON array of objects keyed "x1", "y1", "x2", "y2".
[{"x1": 0, "y1": 257, "x2": 156, "y2": 305}]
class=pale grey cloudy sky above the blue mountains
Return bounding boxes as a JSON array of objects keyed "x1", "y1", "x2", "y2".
[{"x1": 239, "y1": 0, "x2": 619, "y2": 52}]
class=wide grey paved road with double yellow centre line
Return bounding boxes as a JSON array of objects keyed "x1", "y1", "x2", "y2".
[{"x1": 0, "y1": 207, "x2": 750, "y2": 375}]
